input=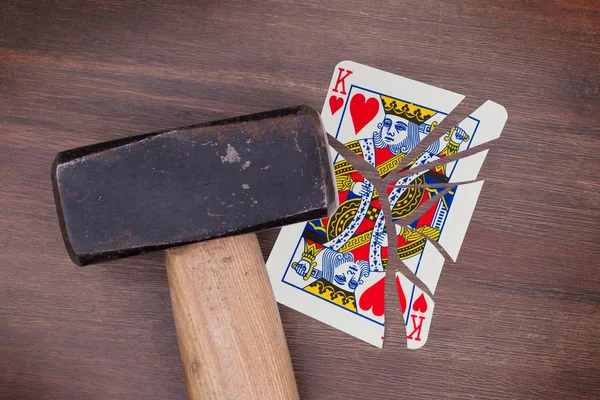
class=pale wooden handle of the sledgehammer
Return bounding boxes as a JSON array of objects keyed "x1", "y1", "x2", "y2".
[{"x1": 166, "y1": 233, "x2": 299, "y2": 400}]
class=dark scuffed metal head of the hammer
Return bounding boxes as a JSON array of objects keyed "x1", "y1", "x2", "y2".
[{"x1": 52, "y1": 106, "x2": 337, "y2": 265}]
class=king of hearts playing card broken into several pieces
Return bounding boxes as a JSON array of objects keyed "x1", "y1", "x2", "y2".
[{"x1": 267, "y1": 61, "x2": 506, "y2": 348}]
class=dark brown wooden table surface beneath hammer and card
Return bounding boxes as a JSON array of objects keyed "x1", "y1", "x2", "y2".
[{"x1": 0, "y1": 0, "x2": 600, "y2": 400}]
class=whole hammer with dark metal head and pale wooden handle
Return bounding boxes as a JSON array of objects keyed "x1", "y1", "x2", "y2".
[{"x1": 52, "y1": 106, "x2": 337, "y2": 400}]
